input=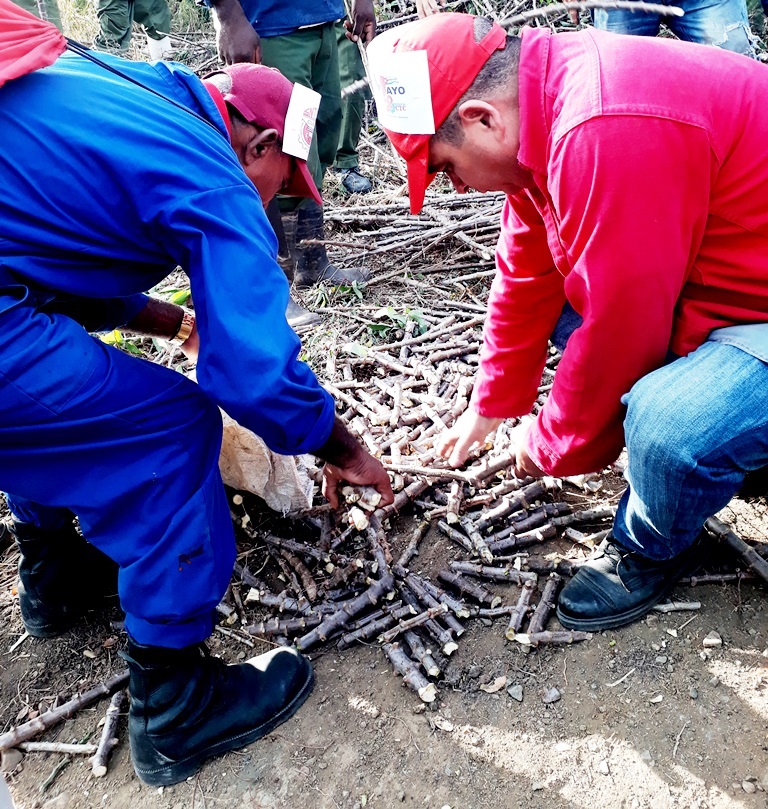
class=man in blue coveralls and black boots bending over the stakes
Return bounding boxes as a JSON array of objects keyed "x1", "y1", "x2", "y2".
[{"x1": 0, "y1": 0, "x2": 393, "y2": 785}]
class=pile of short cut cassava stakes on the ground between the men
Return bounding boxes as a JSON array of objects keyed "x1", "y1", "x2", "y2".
[{"x1": 220, "y1": 308, "x2": 765, "y2": 702}]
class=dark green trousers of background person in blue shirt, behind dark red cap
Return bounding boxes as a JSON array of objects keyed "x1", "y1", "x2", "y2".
[{"x1": 261, "y1": 22, "x2": 341, "y2": 188}]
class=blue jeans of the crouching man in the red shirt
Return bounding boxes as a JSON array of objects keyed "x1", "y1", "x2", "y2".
[{"x1": 553, "y1": 305, "x2": 768, "y2": 560}]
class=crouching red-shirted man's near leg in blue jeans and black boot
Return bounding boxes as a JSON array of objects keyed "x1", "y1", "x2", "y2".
[{"x1": 558, "y1": 342, "x2": 768, "y2": 631}]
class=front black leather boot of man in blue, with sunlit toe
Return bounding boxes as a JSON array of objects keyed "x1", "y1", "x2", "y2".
[{"x1": 123, "y1": 641, "x2": 315, "y2": 786}]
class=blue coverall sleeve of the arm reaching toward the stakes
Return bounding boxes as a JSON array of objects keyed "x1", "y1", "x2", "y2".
[{"x1": 161, "y1": 183, "x2": 334, "y2": 455}]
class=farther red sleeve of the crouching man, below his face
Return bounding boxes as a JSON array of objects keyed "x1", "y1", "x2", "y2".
[{"x1": 472, "y1": 189, "x2": 565, "y2": 418}]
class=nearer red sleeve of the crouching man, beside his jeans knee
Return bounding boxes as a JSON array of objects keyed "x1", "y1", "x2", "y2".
[{"x1": 527, "y1": 115, "x2": 714, "y2": 475}]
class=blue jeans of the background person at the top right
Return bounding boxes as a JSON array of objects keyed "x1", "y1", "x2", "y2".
[{"x1": 592, "y1": 0, "x2": 755, "y2": 59}]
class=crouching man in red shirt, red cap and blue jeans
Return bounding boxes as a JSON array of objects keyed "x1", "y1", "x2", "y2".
[{"x1": 369, "y1": 14, "x2": 768, "y2": 630}]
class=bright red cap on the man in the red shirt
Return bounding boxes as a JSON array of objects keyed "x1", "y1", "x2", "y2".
[{"x1": 368, "y1": 12, "x2": 507, "y2": 213}]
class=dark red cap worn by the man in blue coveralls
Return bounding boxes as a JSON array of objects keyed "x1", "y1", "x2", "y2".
[{"x1": 203, "y1": 63, "x2": 323, "y2": 205}]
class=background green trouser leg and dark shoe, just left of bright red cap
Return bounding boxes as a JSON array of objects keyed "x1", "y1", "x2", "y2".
[{"x1": 333, "y1": 22, "x2": 372, "y2": 194}]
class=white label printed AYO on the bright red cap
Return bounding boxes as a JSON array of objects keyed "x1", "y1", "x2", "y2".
[{"x1": 368, "y1": 30, "x2": 435, "y2": 135}]
